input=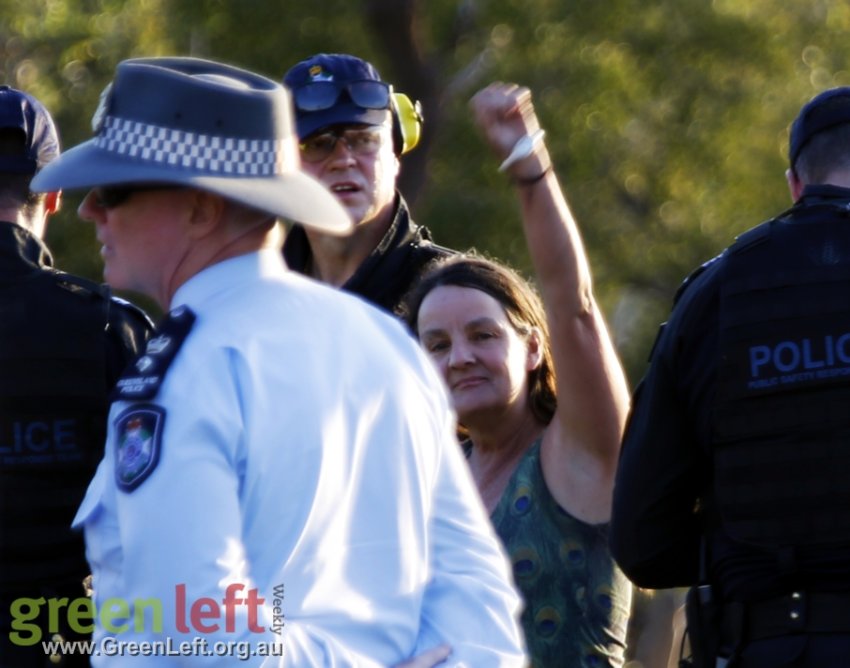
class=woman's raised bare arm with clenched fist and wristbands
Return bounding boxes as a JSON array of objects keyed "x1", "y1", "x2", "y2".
[{"x1": 472, "y1": 83, "x2": 629, "y2": 523}]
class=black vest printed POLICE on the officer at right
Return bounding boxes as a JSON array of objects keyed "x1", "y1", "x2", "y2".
[{"x1": 712, "y1": 204, "x2": 850, "y2": 549}]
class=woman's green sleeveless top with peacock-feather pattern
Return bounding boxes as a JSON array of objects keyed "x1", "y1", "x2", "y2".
[{"x1": 476, "y1": 440, "x2": 632, "y2": 668}]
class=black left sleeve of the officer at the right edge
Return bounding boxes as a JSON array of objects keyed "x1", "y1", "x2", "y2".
[{"x1": 610, "y1": 264, "x2": 717, "y2": 589}]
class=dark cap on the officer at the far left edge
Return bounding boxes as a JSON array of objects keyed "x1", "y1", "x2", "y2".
[{"x1": 0, "y1": 84, "x2": 59, "y2": 174}]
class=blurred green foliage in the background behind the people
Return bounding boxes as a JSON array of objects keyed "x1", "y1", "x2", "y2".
[{"x1": 6, "y1": 0, "x2": 850, "y2": 384}]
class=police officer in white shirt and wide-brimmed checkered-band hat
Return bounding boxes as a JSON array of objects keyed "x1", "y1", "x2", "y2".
[{"x1": 33, "y1": 58, "x2": 525, "y2": 668}]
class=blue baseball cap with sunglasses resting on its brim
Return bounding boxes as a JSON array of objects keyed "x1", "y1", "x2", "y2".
[{"x1": 283, "y1": 53, "x2": 392, "y2": 139}]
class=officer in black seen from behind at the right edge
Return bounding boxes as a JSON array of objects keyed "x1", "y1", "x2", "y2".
[{"x1": 611, "y1": 88, "x2": 850, "y2": 668}]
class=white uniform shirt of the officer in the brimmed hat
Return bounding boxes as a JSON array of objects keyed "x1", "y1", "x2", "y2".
[{"x1": 75, "y1": 251, "x2": 524, "y2": 668}]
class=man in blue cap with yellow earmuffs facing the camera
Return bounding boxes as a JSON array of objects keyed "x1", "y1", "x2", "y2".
[{"x1": 283, "y1": 54, "x2": 451, "y2": 312}]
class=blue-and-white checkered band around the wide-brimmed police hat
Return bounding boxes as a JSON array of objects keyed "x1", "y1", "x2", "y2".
[{"x1": 95, "y1": 116, "x2": 284, "y2": 176}]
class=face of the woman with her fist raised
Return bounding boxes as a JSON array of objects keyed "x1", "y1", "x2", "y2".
[{"x1": 417, "y1": 285, "x2": 540, "y2": 426}]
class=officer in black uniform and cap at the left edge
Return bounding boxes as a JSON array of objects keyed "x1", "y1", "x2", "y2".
[{"x1": 0, "y1": 86, "x2": 151, "y2": 668}]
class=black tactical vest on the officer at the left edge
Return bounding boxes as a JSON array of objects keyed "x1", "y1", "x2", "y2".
[{"x1": 0, "y1": 271, "x2": 109, "y2": 597}]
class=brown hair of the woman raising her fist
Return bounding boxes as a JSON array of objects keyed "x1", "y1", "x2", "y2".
[{"x1": 402, "y1": 252, "x2": 557, "y2": 424}]
